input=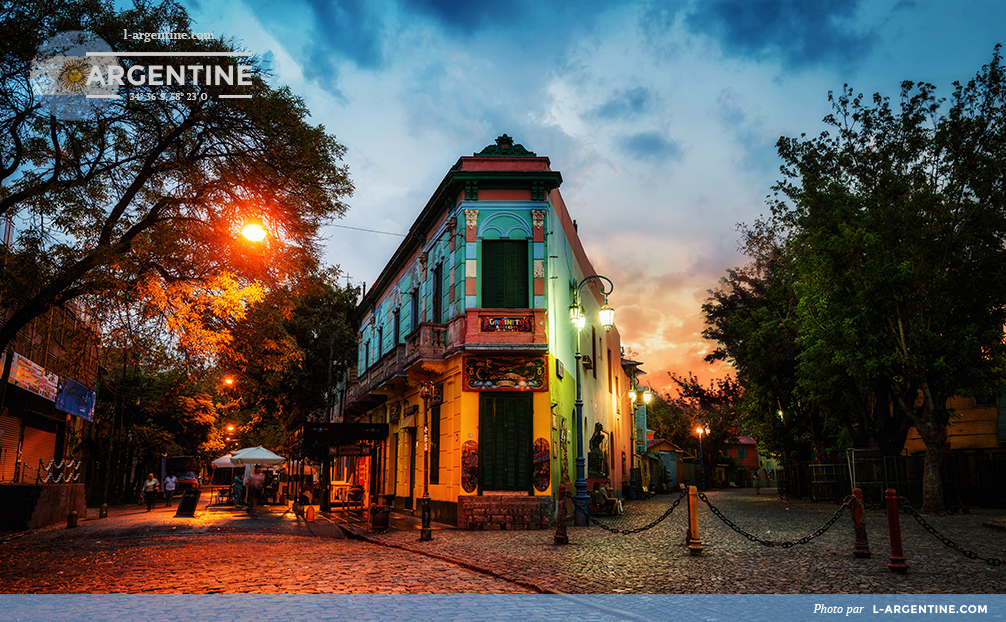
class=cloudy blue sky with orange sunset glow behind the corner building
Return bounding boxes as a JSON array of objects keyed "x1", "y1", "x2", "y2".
[{"x1": 182, "y1": 0, "x2": 1006, "y2": 391}]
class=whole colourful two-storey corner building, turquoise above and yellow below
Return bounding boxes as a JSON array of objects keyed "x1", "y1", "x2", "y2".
[{"x1": 340, "y1": 135, "x2": 632, "y2": 528}]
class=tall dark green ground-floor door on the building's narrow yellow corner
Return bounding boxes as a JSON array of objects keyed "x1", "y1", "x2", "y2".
[{"x1": 479, "y1": 392, "x2": 532, "y2": 490}]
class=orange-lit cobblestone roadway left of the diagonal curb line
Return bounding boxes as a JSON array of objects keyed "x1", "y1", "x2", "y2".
[{"x1": 0, "y1": 499, "x2": 535, "y2": 594}]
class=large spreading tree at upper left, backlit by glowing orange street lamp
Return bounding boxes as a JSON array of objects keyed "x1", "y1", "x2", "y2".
[{"x1": 0, "y1": 0, "x2": 352, "y2": 349}]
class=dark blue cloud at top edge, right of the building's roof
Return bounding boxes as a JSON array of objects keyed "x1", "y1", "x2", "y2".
[{"x1": 685, "y1": 0, "x2": 875, "y2": 68}]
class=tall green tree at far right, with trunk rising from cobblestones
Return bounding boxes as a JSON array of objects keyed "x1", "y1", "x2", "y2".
[{"x1": 773, "y1": 47, "x2": 1006, "y2": 510}]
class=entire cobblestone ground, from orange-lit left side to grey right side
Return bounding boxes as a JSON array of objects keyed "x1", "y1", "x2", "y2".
[{"x1": 0, "y1": 489, "x2": 1006, "y2": 594}]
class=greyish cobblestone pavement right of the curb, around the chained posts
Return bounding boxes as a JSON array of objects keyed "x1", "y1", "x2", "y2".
[{"x1": 342, "y1": 489, "x2": 1006, "y2": 594}]
